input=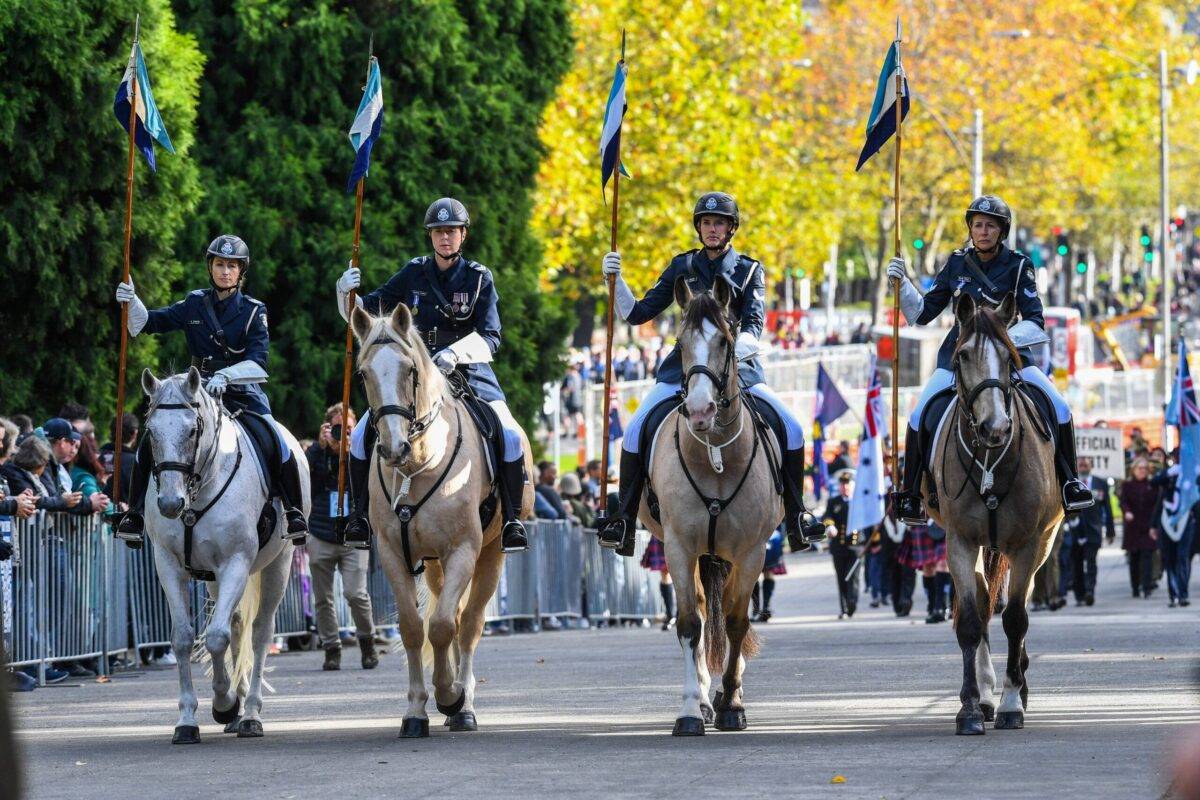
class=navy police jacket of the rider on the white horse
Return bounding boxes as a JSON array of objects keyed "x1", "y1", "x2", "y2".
[{"x1": 144, "y1": 288, "x2": 271, "y2": 417}]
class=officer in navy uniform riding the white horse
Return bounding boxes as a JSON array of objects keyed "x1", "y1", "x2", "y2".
[{"x1": 114, "y1": 234, "x2": 308, "y2": 548}]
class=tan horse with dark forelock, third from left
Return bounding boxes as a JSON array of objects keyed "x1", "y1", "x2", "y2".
[{"x1": 640, "y1": 281, "x2": 784, "y2": 736}]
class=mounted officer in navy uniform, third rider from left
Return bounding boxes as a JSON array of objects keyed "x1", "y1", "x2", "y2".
[{"x1": 599, "y1": 192, "x2": 824, "y2": 555}]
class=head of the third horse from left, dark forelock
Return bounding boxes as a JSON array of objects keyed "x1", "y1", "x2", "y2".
[{"x1": 674, "y1": 278, "x2": 738, "y2": 432}]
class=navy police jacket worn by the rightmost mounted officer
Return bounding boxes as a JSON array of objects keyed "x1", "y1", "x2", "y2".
[{"x1": 916, "y1": 245, "x2": 1046, "y2": 369}]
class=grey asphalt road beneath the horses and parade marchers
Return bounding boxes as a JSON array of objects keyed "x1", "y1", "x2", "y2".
[{"x1": 16, "y1": 548, "x2": 1200, "y2": 800}]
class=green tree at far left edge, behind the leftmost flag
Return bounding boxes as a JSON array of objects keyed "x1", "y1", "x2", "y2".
[{"x1": 0, "y1": 0, "x2": 203, "y2": 425}]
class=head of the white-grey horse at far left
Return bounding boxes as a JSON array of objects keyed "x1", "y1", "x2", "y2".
[{"x1": 142, "y1": 367, "x2": 221, "y2": 519}]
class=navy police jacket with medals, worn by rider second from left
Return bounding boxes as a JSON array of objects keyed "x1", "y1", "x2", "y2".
[{"x1": 362, "y1": 255, "x2": 504, "y2": 402}]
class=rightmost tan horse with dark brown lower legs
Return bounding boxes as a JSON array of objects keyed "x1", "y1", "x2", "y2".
[{"x1": 925, "y1": 294, "x2": 1063, "y2": 735}]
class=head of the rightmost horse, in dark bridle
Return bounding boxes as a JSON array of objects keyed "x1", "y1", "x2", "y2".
[{"x1": 952, "y1": 293, "x2": 1021, "y2": 449}]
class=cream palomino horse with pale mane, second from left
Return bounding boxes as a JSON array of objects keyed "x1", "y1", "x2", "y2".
[{"x1": 350, "y1": 303, "x2": 533, "y2": 738}]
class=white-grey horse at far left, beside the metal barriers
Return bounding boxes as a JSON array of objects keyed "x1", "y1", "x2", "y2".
[{"x1": 142, "y1": 367, "x2": 311, "y2": 745}]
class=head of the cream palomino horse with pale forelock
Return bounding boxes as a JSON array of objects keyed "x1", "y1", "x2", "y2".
[{"x1": 350, "y1": 303, "x2": 445, "y2": 468}]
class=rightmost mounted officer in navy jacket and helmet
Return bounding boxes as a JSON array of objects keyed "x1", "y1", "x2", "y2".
[{"x1": 888, "y1": 194, "x2": 1094, "y2": 525}]
